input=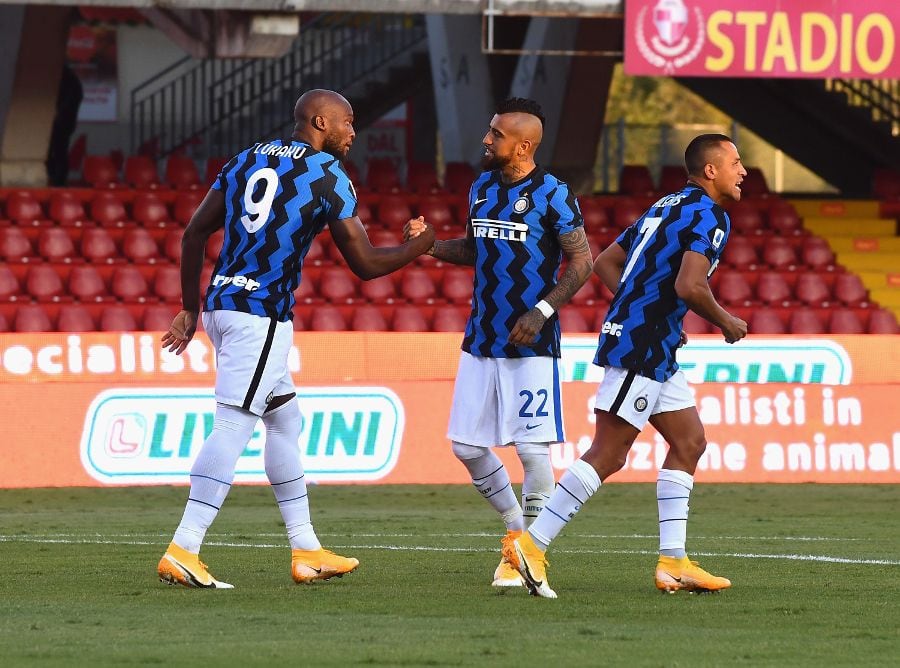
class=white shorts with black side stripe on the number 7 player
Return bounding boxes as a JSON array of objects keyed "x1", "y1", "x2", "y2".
[{"x1": 594, "y1": 366, "x2": 696, "y2": 429}]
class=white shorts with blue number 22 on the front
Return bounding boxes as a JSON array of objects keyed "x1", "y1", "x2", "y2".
[{"x1": 447, "y1": 351, "x2": 565, "y2": 447}]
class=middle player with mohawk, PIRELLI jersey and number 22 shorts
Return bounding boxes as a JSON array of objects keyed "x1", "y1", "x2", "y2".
[{"x1": 408, "y1": 98, "x2": 592, "y2": 587}]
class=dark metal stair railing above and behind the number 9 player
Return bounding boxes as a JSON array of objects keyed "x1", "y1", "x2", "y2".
[{"x1": 131, "y1": 14, "x2": 426, "y2": 158}]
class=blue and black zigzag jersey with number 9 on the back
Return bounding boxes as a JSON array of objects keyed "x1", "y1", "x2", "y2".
[{"x1": 204, "y1": 139, "x2": 356, "y2": 321}]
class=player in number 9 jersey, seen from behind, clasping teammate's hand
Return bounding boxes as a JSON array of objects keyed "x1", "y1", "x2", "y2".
[{"x1": 157, "y1": 90, "x2": 434, "y2": 589}]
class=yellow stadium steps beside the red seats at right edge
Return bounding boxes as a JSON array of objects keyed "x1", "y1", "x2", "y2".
[{"x1": 792, "y1": 199, "x2": 900, "y2": 319}]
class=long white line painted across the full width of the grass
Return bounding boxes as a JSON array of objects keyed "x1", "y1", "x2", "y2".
[{"x1": 0, "y1": 535, "x2": 900, "y2": 566}]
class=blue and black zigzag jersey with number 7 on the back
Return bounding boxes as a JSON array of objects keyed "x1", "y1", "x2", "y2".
[{"x1": 594, "y1": 184, "x2": 731, "y2": 382}]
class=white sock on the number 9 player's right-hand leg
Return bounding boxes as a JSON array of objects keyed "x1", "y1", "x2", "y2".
[{"x1": 263, "y1": 399, "x2": 322, "y2": 550}]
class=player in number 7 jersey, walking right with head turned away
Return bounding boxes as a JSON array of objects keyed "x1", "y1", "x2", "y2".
[{"x1": 506, "y1": 134, "x2": 747, "y2": 598}]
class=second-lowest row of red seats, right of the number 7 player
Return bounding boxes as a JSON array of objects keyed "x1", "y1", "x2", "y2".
[{"x1": 713, "y1": 271, "x2": 869, "y2": 306}]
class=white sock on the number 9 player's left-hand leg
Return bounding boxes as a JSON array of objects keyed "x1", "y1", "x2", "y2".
[{"x1": 172, "y1": 404, "x2": 259, "y2": 554}]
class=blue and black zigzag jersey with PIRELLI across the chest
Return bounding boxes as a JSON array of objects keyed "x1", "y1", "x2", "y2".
[{"x1": 462, "y1": 167, "x2": 584, "y2": 357}]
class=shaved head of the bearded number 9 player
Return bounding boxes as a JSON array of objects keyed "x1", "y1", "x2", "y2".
[{"x1": 294, "y1": 88, "x2": 356, "y2": 158}]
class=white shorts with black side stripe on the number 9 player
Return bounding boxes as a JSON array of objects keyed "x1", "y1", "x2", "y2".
[{"x1": 202, "y1": 311, "x2": 295, "y2": 415}]
